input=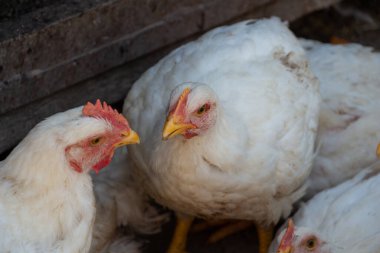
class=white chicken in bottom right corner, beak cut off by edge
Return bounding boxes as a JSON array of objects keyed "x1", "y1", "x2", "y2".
[{"x1": 269, "y1": 162, "x2": 380, "y2": 253}]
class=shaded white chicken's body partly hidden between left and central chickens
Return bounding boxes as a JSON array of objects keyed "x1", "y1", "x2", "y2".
[{"x1": 90, "y1": 149, "x2": 168, "y2": 253}]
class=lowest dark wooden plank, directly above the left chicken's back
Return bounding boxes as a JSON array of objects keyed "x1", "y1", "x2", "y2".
[{"x1": 0, "y1": 41, "x2": 172, "y2": 153}]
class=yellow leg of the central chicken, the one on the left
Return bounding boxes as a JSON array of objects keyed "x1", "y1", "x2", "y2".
[{"x1": 167, "y1": 215, "x2": 194, "y2": 253}]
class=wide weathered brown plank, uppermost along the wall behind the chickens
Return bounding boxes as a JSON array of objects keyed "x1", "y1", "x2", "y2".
[{"x1": 0, "y1": 0, "x2": 269, "y2": 114}]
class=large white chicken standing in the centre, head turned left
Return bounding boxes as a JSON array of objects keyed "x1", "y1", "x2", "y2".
[{"x1": 123, "y1": 18, "x2": 319, "y2": 253}]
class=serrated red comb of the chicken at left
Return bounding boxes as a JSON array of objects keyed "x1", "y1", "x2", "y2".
[{"x1": 82, "y1": 99, "x2": 129, "y2": 129}]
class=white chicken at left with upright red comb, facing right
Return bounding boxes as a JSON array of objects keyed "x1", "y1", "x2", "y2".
[{"x1": 0, "y1": 100, "x2": 139, "y2": 253}]
